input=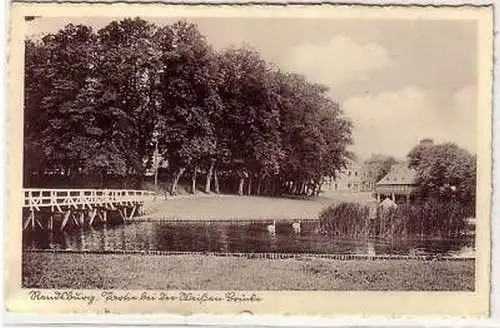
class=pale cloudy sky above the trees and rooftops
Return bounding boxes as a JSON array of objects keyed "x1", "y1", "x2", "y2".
[{"x1": 27, "y1": 17, "x2": 478, "y2": 159}]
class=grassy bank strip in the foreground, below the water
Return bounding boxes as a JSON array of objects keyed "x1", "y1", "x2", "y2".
[{"x1": 23, "y1": 253, "x2": 474, "y2": 290}]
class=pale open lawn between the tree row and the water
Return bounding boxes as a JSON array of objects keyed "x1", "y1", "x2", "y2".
[{"x1": 144, "y1": 193, "x2": 375, "y2": 220}]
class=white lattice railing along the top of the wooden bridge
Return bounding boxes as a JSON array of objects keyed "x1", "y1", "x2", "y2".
[{"x1": 23, "y1": 188, "x2": 156, "y2": 210}]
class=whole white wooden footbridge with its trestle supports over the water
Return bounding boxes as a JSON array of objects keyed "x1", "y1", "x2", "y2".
[{"x1": 23, "y1": 189, "x2": 157, "y2": 230}]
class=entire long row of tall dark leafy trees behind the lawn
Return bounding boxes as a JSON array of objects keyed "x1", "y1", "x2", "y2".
[{"x1": 24, "y1": 18, "x2": 352, "y2": 194}]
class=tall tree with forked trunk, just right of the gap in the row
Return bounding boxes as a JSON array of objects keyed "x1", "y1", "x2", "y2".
[{"x1": 156, "y1": 21, "x2": 221, "y2": 193}]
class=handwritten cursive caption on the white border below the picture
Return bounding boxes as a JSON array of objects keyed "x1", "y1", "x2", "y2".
[{"x1": 28, "y1": 290, "x2": 262, "y2": 306}]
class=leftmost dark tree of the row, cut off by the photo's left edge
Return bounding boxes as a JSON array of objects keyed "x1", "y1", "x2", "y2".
[{"x1": 25, "y1": 24, "x2": 101, "y2": 184}]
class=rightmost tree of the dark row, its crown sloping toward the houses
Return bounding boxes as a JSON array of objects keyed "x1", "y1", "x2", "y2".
[{"x1": 277, "y1": 72, "x2": 352, "y2": 194}]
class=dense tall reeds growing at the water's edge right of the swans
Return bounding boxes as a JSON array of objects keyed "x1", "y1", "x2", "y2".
[{"x1": 319, "y1": 199, "x2": 470, "y2": 239}]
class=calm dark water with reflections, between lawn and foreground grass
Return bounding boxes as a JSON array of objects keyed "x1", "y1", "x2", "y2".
[{"x1": 23, "y1": 222, "x2": 473, "y2": 255}]
